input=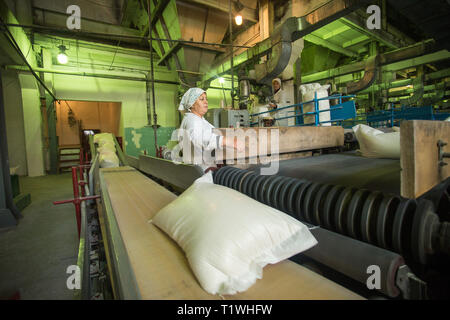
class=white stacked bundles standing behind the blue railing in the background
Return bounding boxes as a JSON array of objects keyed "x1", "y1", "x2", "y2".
[{"x1": 300, "y1": 83, "x2": 331, "y2": 126}]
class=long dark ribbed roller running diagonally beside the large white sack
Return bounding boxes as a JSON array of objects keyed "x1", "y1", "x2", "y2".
[{"x1": 214, "y1": 167, "x2": 450, "y2": 264}]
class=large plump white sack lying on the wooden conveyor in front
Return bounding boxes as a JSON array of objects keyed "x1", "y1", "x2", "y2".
[{"x1": 152, "y1": 172, "x2": 317, "y2": 294}]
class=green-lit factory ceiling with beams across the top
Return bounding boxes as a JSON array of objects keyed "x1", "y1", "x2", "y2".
[{"x1": 0, "y1": 0, "x2": 450, "y2": 102}]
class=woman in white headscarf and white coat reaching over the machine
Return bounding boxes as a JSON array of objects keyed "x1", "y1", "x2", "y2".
[{"x1": 178, "y1": 88, "x2": 244, "y2": 170}]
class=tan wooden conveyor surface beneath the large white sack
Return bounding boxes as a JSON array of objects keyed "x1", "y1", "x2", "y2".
[{"x1": 96, "y1": 167, "x2": 361, "y2": 300}]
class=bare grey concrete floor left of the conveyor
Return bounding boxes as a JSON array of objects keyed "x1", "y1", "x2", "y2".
[{"x1": 0, "y1": 173, "x2": 78, "y2": 300}]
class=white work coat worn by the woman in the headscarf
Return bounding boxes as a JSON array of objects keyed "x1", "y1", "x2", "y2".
[{"x1": 178, "y1": 112, "x2": 223, "y2": 169}]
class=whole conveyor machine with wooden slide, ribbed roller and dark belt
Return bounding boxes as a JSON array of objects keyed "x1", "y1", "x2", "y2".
[{"x1": 71, "y1": 117, "x2": 450, "y2": 299}]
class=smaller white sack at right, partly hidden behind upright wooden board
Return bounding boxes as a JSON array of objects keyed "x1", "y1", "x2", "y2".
[{"x1": 353, "y1": 124, "x2": 400, "y2": 159}]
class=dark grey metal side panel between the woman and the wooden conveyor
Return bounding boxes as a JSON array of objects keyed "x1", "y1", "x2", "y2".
[{"x1": 139, "y1": 155, "x2": 203, "y2": 189}]
